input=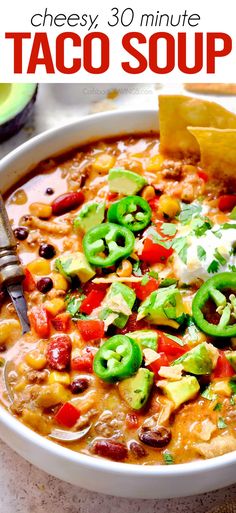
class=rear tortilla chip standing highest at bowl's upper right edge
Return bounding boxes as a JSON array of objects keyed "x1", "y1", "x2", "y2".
[{"x1": 159, "y1": 95, "x2": 236, "y2": 158}]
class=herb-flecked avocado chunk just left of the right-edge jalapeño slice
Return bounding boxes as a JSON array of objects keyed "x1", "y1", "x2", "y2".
[{"x1": 137, "y1": 285, "x2": 185, "y2": 329}]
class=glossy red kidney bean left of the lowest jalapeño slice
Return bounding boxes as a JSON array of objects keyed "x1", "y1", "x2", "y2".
[{"x1": 46, "y1": 335, "x2": 71, "y2": 370}]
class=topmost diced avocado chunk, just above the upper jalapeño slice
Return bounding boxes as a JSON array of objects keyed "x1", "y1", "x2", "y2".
[{"x1": 108, "y1": 167, "x2": 147, "y2": 196}]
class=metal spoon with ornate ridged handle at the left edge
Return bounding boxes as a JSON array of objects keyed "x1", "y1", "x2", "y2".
[{"x1": 0, "y1": 194, "x2": 30, "y2": 335}]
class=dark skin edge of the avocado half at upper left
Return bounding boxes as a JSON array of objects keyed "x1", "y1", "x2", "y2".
[{"x1": 0, "y1": 85, "x2": 38, "y2": 142}]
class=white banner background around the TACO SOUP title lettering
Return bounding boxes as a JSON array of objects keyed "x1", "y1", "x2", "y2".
[{"x1": 0, "y1": 0, "x2": 236, "y2": 83}]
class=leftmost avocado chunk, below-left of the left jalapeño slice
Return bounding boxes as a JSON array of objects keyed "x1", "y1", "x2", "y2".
[{"x1": 55, "y1": 251, "x2": 95, "y2": 283}]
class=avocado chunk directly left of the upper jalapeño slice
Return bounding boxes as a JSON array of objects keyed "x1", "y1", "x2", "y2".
[{"x1": 73, "y1": 201, "x2": 105, "y2": 232}]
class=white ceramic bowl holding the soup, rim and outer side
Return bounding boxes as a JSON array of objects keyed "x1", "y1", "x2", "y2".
[{"x1": 0, "y1": 110, "x2": 236, "y2": 499}]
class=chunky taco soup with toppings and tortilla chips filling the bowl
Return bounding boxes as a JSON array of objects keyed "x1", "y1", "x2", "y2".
[{"x1": 0, "y1": 97, "x2": 236, "y2": 465}]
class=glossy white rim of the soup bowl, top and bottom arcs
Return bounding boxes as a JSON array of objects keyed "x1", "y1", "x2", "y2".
[{"x1": 0, "y1": 108, "x2": 236, "y2": 478}]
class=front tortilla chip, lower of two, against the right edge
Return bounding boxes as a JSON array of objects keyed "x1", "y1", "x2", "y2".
[{"x1": 188, "y1": 127, "x2": 236, "y2": 183}]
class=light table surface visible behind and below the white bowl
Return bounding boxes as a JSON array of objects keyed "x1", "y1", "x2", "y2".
[{"x1": 0, "y1": 84, "x2": 236, "y2": 513}]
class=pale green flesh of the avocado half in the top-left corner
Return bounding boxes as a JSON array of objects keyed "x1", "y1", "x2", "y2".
[{"x1": 0, "y1": 83, "x2": 38, "y2": 142}]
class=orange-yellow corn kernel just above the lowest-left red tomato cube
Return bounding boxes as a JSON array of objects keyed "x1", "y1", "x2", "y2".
[{"x1": 36, "y1": 383, "x2": 70, "y2": 408}]
